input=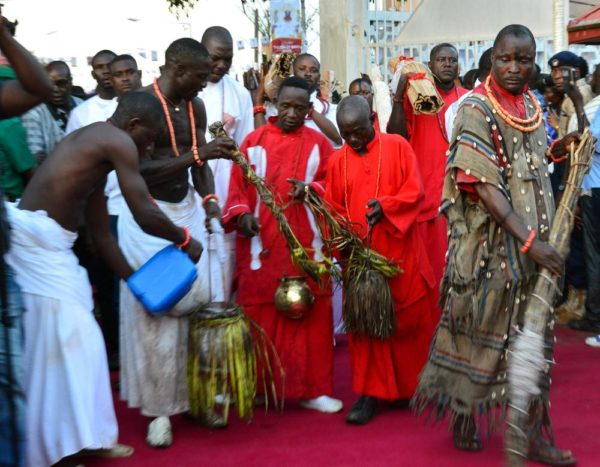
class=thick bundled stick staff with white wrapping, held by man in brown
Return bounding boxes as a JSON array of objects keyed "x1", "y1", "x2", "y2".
[{"x1": 504, "y1": 130, "x2": 594, "y2": 466}]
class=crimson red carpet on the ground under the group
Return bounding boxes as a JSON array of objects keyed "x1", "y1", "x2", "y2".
[{"x1": 85, "y1": 328, "x2": 600, "y2": 467}]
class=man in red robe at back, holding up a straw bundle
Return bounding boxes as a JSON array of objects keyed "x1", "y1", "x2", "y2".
[{"x1": 388, "y1": 43, "x2": 468, "y2": 306}]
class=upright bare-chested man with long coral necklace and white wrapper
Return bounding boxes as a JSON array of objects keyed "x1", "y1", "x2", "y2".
[{"x1": 119, "y1": 38, "x2": 235, "y2": 447}]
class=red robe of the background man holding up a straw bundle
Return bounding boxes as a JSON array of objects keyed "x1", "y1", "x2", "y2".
[{"x1": 404, "y1": 86, "x2": 468, "y2": 310}]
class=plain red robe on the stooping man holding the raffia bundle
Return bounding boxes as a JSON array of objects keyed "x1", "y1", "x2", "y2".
[{"x1": 325, "y1": 133, "x2": 435, "y2": 400}]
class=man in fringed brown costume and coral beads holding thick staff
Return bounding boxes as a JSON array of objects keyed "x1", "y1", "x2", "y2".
[{"x1": 413, "y1": 24, "x2": 576, "y2": 465}]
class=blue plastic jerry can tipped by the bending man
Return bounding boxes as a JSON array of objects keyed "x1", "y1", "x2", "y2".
[{"x1": 127, "y1": 245, "x2": 198, "y2": 314}]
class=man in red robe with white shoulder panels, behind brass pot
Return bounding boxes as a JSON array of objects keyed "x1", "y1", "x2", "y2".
[{"x1": 223, "y1": 77, "x2": 342, "y2": 413}]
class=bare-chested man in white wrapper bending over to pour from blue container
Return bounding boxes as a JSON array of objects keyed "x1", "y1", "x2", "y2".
[{"x1": 7, "y1": 93, "x2": 202, "y2": 465}]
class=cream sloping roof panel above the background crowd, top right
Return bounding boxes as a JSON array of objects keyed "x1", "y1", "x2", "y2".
[{"x1": 394, "y1": 0, "x2": 568, "y2": 45}]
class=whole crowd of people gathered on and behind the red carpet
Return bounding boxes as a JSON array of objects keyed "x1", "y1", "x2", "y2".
[{"x1": 0, "y1": 4, "x2": 600, "y2": 467}]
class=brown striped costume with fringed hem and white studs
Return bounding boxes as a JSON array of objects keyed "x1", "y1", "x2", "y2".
[{"x1": 413, "y1": 78, "x2": 554, "y2": 434}]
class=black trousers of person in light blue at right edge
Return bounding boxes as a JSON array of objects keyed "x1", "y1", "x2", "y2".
[{"x1": 580, "y1": 188, "x2": 600, "y2": 324}]
